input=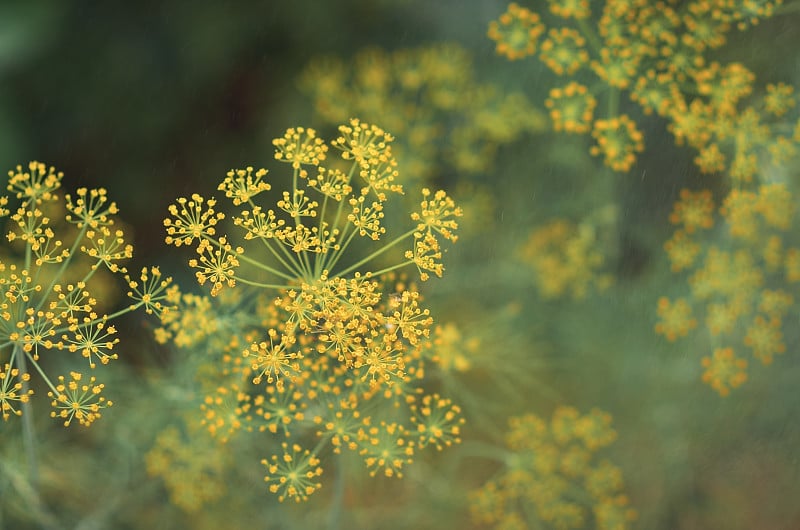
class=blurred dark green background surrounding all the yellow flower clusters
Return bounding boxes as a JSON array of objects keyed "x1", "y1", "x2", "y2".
[{"x1": 0, "y1": 0, "x2": 800, "y2": 530}]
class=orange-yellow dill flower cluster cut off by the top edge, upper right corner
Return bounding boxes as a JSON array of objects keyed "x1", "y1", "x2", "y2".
[{"x1": 488, "y1": 0, "x2": 796, "y2": 174}]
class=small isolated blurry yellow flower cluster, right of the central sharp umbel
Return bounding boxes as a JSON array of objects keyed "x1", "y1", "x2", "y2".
[{"x1": 519, "y1": 219, "x2": 612, "y2": 299}]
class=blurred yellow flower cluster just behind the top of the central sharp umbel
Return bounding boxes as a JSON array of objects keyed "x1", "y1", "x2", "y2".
[{"x1": 300, "y1": 44, "x2": 546, "y2": 177}]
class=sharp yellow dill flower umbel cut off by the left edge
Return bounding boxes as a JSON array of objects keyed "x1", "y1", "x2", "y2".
[{"x1": 0, "y1": 162, "x2": 175, "y2": 425}]
